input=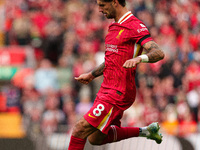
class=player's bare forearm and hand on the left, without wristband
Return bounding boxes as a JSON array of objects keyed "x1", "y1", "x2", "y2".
[{"x1": 75, "y1": 62, "x2": 105, "y2": 84}]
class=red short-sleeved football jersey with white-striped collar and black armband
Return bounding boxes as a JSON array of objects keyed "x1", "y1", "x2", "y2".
[{"x1": 98, "y1": 11, "x2": 152, "y2": 109}]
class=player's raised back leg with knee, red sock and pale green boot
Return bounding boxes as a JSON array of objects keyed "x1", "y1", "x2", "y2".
[{"x1": 88, "y1": 123, "x2": 162, "y2": 145}]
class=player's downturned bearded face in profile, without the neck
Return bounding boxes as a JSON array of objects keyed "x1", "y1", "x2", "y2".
[{"x1": 97, "y1": 0, "x2": 116, "y2": 19}]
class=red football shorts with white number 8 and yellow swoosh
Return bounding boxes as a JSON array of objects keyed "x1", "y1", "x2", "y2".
[{"x1": 84, "y1": 101, "x2": 123, "y2": 134}]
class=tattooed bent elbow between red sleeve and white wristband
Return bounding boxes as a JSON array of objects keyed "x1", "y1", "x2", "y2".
[{"x1": 143, "y1": 41, "x2": 164, "y2": 63}]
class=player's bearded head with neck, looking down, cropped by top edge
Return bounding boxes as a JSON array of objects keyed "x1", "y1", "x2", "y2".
[{"x1": 97, "y1": 0, "x2": 126, "y2": 19}]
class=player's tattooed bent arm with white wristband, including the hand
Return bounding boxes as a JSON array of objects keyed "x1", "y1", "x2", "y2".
[{"x1": 123, "y1": 41, "x2": 165, "y2": 68}]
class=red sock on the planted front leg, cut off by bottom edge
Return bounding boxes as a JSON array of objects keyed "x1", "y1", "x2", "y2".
[{"x1": 68, "y1": 136, "x2": 86, "y2": 150}]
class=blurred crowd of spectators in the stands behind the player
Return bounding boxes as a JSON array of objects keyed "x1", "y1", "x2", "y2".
[{"x1": 0, "y1": 0, "x2": 200, "y2": 136}]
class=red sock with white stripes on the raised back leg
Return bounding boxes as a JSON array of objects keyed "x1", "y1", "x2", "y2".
[{"x1": 102, "y1": 126, "x2": 139, "y2": 144}]
